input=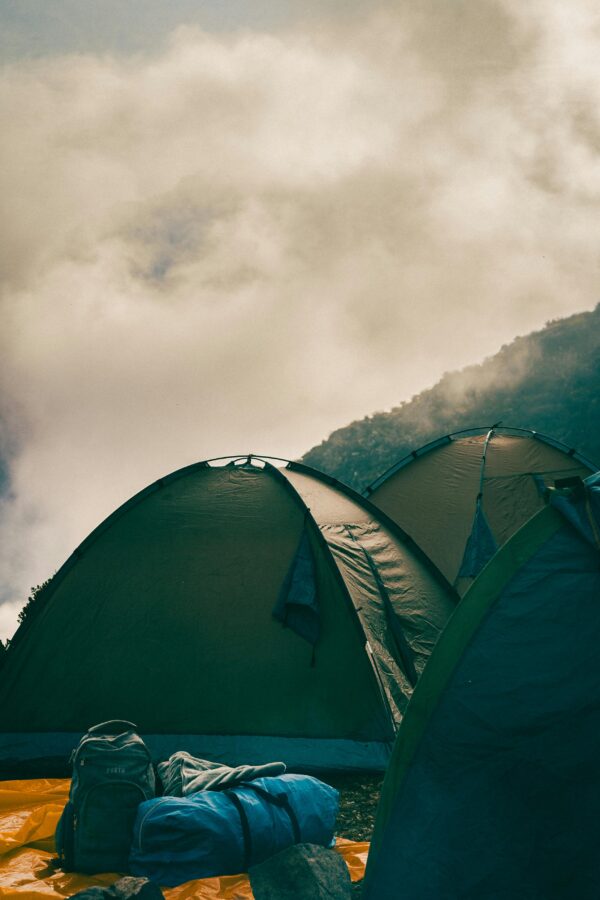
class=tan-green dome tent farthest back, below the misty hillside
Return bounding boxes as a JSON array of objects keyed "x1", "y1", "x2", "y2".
[{"x1": 365, "y1": 425, "x2": 598, "y2": 595}]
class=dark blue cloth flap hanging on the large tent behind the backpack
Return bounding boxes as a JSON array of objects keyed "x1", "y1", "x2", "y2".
[{"x1": 273, "y1": 527, "x2": 321, "y2": 647}]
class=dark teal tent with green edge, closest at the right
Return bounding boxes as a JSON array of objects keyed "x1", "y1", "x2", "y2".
[{"x1": 364, "y1": 474, "x2": 600, "y2": 900}]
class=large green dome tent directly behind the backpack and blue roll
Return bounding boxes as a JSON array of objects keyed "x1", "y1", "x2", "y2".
[{"x1": 0, "y1": 457, "x2": 456, "y2": 773}]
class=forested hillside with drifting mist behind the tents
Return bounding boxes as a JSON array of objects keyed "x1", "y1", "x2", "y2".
[{"x1": 302, "y1": 304, "x2": 600, "y2": 490}]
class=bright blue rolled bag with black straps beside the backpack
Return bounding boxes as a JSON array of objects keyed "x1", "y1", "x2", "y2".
[{"x1": 129, "y1": 775, "x2": 339, "y2": 887}]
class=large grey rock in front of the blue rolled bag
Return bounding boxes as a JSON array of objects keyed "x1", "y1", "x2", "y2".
[{"x1": 248, "y1": 844, "x2": 352, "y2": 900}]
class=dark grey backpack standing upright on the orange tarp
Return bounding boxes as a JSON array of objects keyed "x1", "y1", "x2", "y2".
[{"x1": 56, "y1": 719, "x2": 156, "y2": 875}]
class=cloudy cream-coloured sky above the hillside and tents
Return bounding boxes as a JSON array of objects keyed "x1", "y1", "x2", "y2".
[{"x1": 0, "y1": 0, "x2": 600, "y2": 637}]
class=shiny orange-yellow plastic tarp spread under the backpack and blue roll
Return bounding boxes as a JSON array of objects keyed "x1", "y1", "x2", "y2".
[{"x1": 0, "y1": 778, "x2": 369, "y2": 900}]
